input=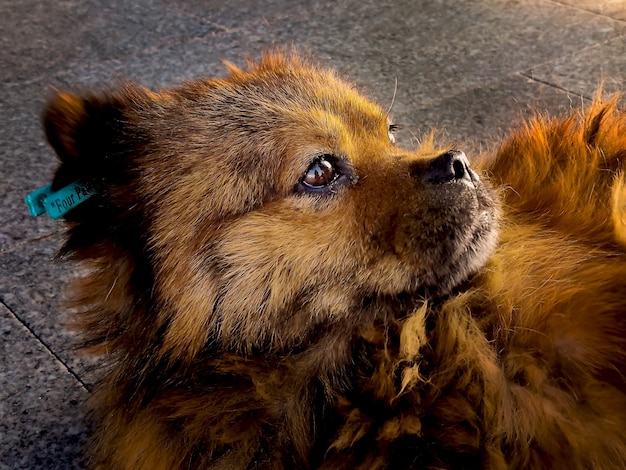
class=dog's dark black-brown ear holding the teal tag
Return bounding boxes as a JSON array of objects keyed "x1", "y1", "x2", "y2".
[{"x1": 43, "y1": 84, "x2": 154, "y2": 254}]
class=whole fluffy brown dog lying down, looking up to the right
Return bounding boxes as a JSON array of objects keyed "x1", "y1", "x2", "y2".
[{"x1": 44, "y1": 54, "x2": 626, "y2": 469}]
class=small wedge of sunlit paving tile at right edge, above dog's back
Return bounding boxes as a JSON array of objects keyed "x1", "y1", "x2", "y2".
[{"x1": 524, "y1": 37, "x2": 626, "y2": 97}]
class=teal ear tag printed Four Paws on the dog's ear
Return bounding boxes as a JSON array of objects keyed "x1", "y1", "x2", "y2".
[{"x1": 26, "y1": 181, "x2": 96, "y2": 219}]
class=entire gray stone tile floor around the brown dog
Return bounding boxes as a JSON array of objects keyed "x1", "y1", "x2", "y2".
[{"x1": 0, "y1": 0, "x2": 626, "y2": 469}]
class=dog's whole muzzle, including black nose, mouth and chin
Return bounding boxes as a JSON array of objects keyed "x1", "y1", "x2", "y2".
[{"x1": 356, "y1": 150, "x2": 499, "y2": 296}]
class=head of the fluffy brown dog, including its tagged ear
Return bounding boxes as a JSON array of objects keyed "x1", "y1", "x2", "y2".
[{"x1": 44, "y1": 54, "x2": 497, "y2": 355}]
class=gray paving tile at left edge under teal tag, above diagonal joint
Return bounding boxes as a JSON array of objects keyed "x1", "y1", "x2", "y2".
[{"x1": 0, "y1": 235, "x2": 97, "y2": 383}]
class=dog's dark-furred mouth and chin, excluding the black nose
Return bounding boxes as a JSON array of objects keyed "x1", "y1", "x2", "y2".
[{"x1": 360, "y1": 171, "x2": 499, "y2": 297}]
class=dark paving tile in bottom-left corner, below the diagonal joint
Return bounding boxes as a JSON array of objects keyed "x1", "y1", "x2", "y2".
[{"x1": 0, "y1": 305, "x2": 88, "y2": 470}]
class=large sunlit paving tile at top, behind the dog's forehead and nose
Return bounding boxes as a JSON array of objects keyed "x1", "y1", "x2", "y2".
[{"x1": 155, "y1": 0, "x2": 626, "y2": 105}]
